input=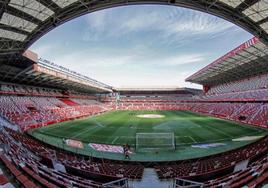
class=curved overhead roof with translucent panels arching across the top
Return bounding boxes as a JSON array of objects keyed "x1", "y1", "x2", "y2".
[{"x1": 0, "y1": 0, "x2": 268, "y2": 60}]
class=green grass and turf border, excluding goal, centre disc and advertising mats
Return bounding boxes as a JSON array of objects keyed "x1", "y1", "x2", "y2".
[{"x1": 28, "y1": 111, "x2": 268, "y2": 161}]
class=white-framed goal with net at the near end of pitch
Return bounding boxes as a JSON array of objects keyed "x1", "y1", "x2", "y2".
[{"x1": 136, "y1": 133, "x2": 175, "y2": 151}]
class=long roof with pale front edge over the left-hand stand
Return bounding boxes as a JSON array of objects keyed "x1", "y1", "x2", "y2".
[{"x1": 0, "y1": 50, "x2": 112, "y2": 93}]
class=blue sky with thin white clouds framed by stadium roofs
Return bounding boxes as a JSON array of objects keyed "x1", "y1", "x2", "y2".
[{"x1": 30, "y1": 5, "x2": 253, "y2": 88}]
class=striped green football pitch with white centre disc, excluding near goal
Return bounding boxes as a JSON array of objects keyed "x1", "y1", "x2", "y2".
[{"x1": 30, "y1": 110, "x2": 267, "y2": 162}]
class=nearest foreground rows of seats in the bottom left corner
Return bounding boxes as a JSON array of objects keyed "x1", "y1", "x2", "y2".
[{"x1": 0, "y1": 131, "x2": 110, "y2": 188}]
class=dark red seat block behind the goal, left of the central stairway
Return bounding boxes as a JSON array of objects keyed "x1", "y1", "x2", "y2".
[{"x1": 7, "y1": 129, "x2": 144, "y2": 179}]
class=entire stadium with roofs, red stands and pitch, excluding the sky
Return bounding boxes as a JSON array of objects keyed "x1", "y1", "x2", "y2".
[{"x1": 0, "y1": 0, "x2": 268, "y2": 188}]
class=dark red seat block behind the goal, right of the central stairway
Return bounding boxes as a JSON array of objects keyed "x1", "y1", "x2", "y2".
[{"x1": 155, "y1": 137, "x2": 268, "y2": 179}]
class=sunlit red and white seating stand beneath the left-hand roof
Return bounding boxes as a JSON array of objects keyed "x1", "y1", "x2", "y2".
[{"x1": 0, "y1": 96, "x2": 106, "y2": 131}]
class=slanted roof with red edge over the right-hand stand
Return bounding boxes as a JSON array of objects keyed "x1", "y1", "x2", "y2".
[{"x1": 186, "y1": 37, "x2": 268, "y2": 86}]
